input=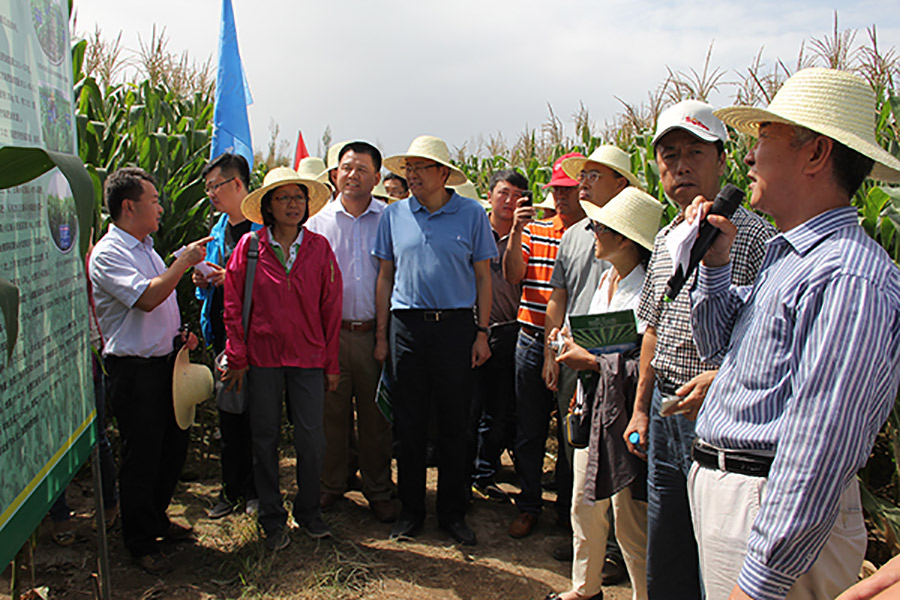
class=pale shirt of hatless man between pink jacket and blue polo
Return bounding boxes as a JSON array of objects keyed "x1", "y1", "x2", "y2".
[{"x1": 306, "y1": 196, "x2": 387, "y2": 321}]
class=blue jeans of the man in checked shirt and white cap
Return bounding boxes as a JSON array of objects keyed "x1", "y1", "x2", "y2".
[{"x1": 647, "y1": 388, "x2": 703, "y2": 599}]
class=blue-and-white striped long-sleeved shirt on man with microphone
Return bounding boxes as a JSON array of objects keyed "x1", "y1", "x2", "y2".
[{"x1": 691, "y1": 207, "x2": 900, "y2": 600}]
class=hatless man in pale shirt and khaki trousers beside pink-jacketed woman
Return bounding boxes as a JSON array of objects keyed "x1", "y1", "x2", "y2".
[{"x1": 306, "y1": 142, "x2": 398, "y2": 523}]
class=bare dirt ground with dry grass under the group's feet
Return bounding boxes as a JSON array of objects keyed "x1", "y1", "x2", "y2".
[{"x1": 0, "y1": 432, "x2": 631, "y2": 600}]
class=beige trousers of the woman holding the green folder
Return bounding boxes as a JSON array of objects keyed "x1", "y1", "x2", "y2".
[{"x1": 572, "y1": 448, "x2": 647, "y2": 600}]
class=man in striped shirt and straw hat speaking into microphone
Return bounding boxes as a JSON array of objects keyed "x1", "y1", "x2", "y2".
[{"x1": 689, "y1": 69, "x2": 900, "y2": 600}]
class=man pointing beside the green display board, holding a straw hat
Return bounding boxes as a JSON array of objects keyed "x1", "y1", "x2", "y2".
[{"x1": 89, "y1": 167, "x2": 212, "y2": 575}]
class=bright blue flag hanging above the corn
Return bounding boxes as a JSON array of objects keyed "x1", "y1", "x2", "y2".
[{"x1": 209, "y1": 0, "x2": 253, "y2": 169}]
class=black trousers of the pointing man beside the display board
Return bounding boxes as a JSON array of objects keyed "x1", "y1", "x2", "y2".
[{"x1": 105, "y1": 356, "x2": 188, "y2": 557}]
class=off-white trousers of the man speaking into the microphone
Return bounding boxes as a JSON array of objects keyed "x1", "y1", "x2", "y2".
[{"x1": 688, "y1": 463, "x2": 866, "y2": 600}]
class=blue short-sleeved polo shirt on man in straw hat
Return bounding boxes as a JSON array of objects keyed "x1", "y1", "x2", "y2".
[{"x1": 372, "y1": 192, "x2": 497, "y2": 310}]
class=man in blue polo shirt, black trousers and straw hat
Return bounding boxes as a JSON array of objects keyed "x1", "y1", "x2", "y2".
[{"x1": 372, "y1": 136, "x2": 497, "y2": 545}]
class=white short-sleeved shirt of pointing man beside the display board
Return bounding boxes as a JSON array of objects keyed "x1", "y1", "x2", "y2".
[{"x1": 88, "y1": 225, "x2": 181, "y2": 358}]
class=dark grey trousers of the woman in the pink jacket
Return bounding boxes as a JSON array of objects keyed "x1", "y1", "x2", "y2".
[{"x1": 247, "y1": 365, "x2": 325, "y2": 536}]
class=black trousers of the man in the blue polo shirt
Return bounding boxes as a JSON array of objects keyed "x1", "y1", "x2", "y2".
[{"x1": 390, "y1": 311, "x2": 475, "y2": 524}]
